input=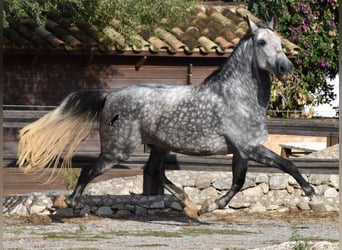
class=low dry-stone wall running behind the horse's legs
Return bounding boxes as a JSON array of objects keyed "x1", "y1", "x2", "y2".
[{"x1": 3, "y1": 171, "x2": 339, "y2": 216}]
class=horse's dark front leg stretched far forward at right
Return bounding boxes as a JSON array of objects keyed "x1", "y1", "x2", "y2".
[{"x1": 248, "y1": 145, "x2": 315, "y2": 196}]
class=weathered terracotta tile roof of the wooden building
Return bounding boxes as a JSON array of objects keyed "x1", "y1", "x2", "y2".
[{"x1": 3, "y1": 4, "x2": 299, "y2": 55}]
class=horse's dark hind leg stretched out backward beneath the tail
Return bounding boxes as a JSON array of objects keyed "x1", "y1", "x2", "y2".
[{"x1": 66, "y1": 154, "x2": 117, "y2": 207}]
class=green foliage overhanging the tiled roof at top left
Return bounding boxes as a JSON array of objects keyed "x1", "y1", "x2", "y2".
[{"x1": 3, "y1": 0, "x2": 195, "y2": 41}]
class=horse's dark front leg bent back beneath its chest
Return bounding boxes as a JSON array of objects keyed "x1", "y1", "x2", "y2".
[{"x1": 200, "y1": 153, "x2": 248, "y2": 214}]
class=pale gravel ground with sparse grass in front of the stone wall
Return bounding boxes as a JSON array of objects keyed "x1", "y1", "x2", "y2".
[{"x1": 3, "y1": 211, "x2": 339, "y2": 249}]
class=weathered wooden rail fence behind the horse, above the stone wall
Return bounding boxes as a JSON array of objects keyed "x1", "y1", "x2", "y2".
[{"x1": 3, "y1": 107, "x2": 339, "y2": 193}]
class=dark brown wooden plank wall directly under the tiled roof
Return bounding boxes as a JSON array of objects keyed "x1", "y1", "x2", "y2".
[{"x1": 4, "y1": 55, "x2": 224, "y2": 106}]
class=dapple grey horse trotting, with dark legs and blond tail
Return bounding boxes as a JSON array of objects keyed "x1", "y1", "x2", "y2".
[{"x1": 18, "y1": 18, "x2": 314, "y2": 217}]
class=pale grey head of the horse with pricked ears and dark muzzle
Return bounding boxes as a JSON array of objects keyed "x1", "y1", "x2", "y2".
[{"x1": 247, "y1": 17, "x2": 292, "y2": 81}]
